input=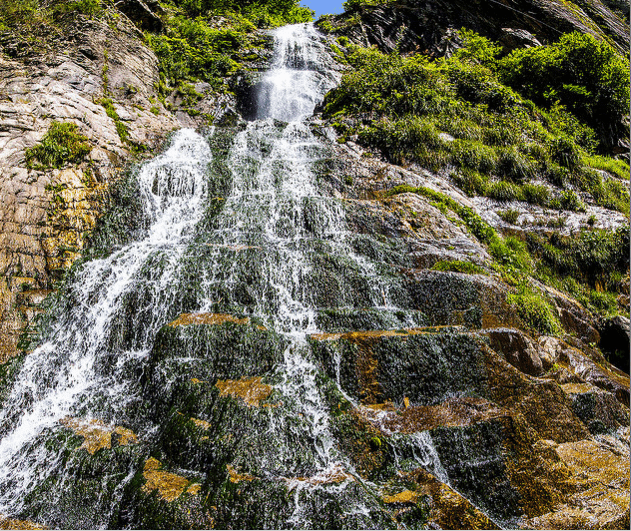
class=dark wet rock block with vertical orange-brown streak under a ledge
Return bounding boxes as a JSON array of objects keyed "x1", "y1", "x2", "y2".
[{"x1": 311, "y1": 329, "x2": 487, "y2": 405}]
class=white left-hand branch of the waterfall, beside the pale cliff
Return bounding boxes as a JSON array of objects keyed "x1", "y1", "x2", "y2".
[{"x1": 0, "y1": 129, "x2": 211, "y2": 514}]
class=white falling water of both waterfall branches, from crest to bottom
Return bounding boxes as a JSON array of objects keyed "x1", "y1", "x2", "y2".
[{"x1": 0, "y1": 24, "x2": 454, "y2": 527}]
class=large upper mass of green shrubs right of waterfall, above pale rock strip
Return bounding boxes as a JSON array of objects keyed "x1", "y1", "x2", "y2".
[{"x1": 325, "y1": 30, "x2": 629, "y2": 212}]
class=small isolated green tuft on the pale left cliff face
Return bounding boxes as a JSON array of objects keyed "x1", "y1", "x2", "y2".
[{"x1": 26, "y1": 122, "x2": 92, "y2": 169}]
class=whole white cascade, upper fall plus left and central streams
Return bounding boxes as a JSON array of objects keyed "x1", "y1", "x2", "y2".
[{"x1": 0, "y1": 24, "x2": 460, "y2": 527}]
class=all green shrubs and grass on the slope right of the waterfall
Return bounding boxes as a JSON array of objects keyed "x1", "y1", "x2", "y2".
[{"x1": 324, "y1": 30, "x2": 629, "y2": 320}]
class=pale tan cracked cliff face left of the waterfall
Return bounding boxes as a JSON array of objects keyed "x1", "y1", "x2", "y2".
[{"x1": 0, "y1": 1, "x2": 247, "y2": 360}]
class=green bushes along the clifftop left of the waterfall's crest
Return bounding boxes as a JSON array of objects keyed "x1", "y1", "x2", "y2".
[{"x1": 0, "y1": 0, "x2": 313, "y2": 92}]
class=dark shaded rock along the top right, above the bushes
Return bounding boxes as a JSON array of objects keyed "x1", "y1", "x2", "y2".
[{"x1": 320, "y1": 0, "x2": 629, "y2": 56}]
